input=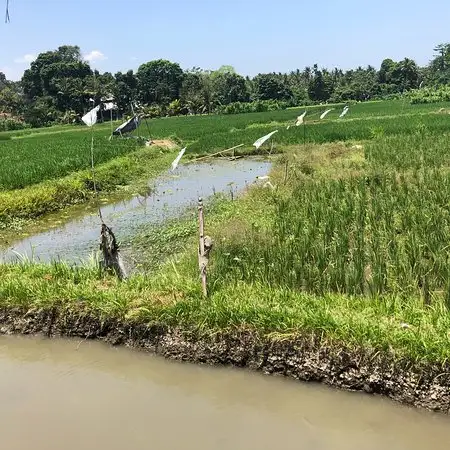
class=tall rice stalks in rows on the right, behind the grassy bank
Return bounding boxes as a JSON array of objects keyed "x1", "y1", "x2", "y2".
[{"x1": 210, "y1": 135, "x2": 450, "y2": 302}]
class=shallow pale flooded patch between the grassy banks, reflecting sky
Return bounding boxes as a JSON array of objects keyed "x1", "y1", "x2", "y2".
[{"x1": 0, "y1": 159, "x2": 270, "y2": 263}]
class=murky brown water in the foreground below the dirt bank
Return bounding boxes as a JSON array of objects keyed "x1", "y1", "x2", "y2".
[{"x1": 0, "y1": 337, "x2": 450, "y2": 450}]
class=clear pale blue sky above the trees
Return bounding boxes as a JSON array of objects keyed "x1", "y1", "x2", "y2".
[{"x1": 0, "y1": 0, "x2": 450, "y2": 80}]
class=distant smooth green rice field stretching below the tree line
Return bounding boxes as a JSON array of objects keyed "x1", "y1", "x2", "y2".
[{"x1": 0, "y1": 101, "x2": 450, "y2": 190}]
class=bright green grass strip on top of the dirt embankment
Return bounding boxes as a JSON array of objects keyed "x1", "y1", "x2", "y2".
[{"x1": 0, "y1": 256, "x2": 450, "y2": 364}]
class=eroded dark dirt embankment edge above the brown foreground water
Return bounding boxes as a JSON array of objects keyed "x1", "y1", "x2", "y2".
[{"x1": 0, "y1": 308, "x2": 450, "y2": 413}]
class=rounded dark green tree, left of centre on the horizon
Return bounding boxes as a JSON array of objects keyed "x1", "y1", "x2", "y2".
[{"x1": 136, "y1": 59, "x2": 183, "y2": 105}]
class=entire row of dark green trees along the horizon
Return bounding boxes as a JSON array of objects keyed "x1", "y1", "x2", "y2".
[{"x1": 0, "y1": 44, "x2": 450, "y2": 126}]
